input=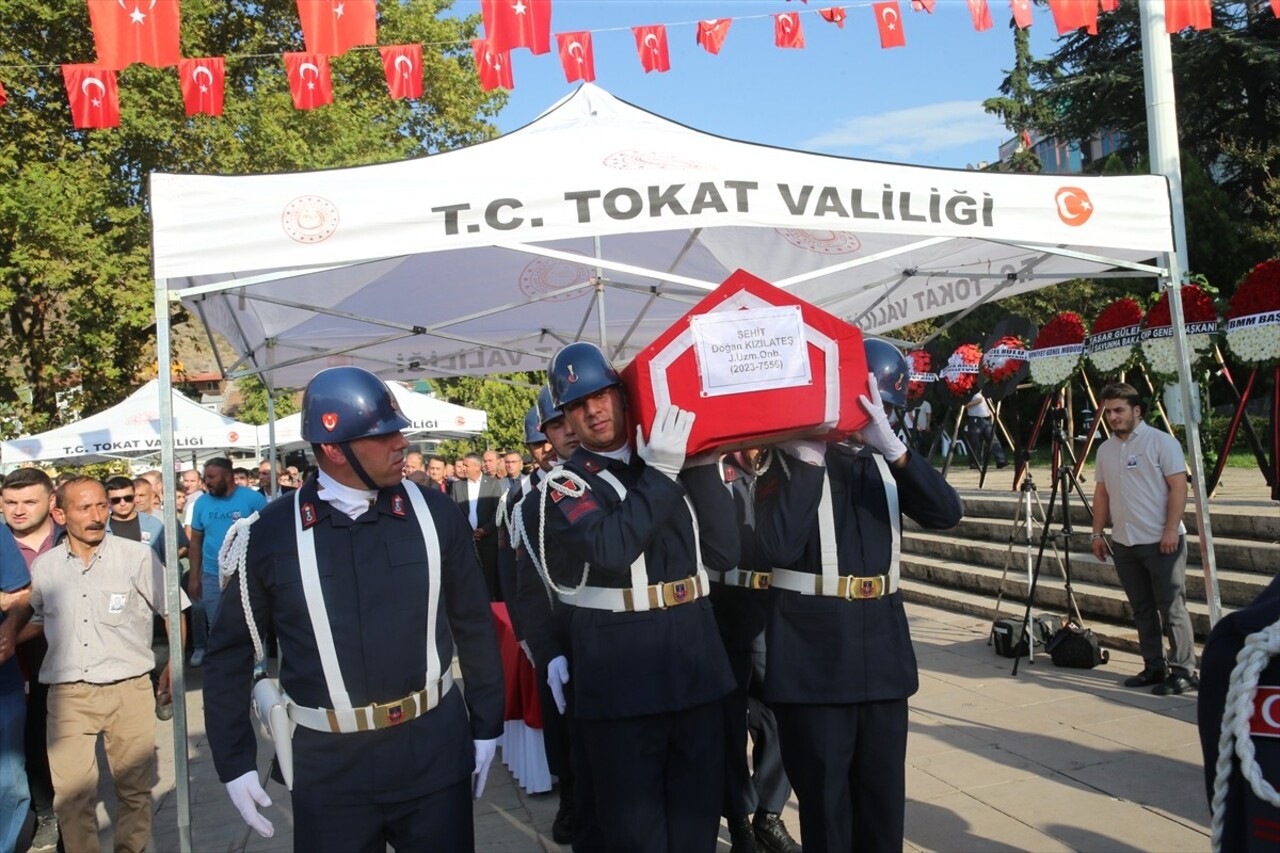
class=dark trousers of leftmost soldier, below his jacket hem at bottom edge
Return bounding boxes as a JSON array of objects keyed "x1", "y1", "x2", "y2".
[{"x1": 293, "y1": 777, "x2": 475, "y2": 853}]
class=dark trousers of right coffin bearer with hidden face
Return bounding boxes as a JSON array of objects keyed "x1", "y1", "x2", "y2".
[{"x1": 773, "y1": 699, "x2": 906, "y2": 853}]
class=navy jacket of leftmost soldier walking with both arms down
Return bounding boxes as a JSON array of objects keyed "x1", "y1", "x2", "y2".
[{"x1": 205, "y1": 479, "x2": 503, "y2": 804}]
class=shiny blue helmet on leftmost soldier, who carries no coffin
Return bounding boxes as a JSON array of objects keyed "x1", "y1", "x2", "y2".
[{"x1": 302, "y1": 366, "x2": 410, "y2": 444}]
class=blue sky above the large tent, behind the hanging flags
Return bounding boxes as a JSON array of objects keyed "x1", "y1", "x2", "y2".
[{"x1": 456, "y1": 0, "x2": 1056, "y2": 168}]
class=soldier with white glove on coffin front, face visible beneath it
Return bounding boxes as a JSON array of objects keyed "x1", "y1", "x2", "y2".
[{"x1": 537, "y1": 343, "x2": 739, "y2": 853}]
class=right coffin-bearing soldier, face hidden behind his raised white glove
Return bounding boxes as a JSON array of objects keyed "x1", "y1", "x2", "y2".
[{"x1": 755, "y1": 341, "x2": 963, "y2": 853}]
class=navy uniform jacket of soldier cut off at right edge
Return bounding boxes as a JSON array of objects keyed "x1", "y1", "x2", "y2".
[{"x1": 1197, "y1": 578, "x2": 1280, "y2": 850}]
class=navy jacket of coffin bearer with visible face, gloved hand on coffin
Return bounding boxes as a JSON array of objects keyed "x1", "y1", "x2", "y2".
[{"x1": 534, "y1": 447, "x2": 739, "y2": 720}]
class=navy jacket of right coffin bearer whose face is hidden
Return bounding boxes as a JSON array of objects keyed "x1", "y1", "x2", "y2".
[{"x1": 755, "y1": 443, "x2": 964, "y2": 704}]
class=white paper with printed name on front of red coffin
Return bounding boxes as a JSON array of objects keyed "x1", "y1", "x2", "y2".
[{"x1": 689, "y1": 305, "x2": 813, "y2": 397}]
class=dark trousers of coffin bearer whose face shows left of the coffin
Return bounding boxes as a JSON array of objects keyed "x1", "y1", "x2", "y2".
[{"x1": 579, "y1": 701, "x2": 724, "y2": 853}]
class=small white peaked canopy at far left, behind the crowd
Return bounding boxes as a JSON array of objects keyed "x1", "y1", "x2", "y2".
[{"x1": 0, "y1": 379, "x2": 259, "y2": 465}]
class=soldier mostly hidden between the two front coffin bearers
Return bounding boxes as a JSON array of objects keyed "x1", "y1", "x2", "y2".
[{"x1": 708, "y1": 450, "x2": 800, "y2": 853}]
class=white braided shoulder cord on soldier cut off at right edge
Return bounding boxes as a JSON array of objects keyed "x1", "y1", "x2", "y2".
[{"x1": 1212, "y1": 621, "x2": 1280, "y2": 850}]
